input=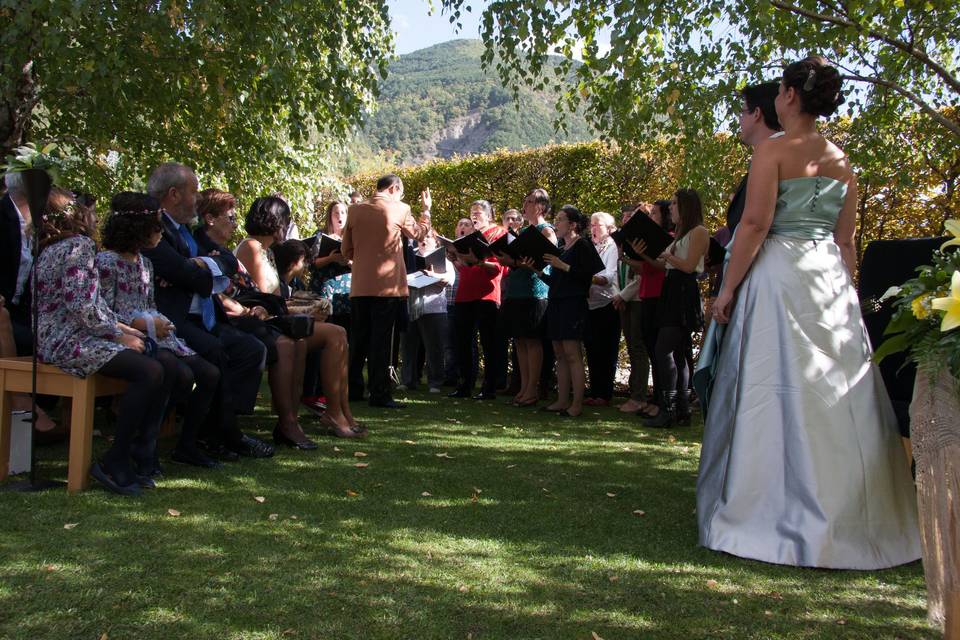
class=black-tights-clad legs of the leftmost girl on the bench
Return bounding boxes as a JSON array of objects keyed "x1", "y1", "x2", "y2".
[{"x1": 97, "y1": 349, "x2": 179, "y2": 476}]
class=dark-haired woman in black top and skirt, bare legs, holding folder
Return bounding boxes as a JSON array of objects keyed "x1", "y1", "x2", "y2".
[{"x1": 521, "y1": 205, "x2": 603, "y2": 417}]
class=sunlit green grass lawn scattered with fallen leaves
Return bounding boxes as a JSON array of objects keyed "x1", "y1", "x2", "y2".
[{"x1": 0, "y1": 393, "x2": 936, "y2": 640}]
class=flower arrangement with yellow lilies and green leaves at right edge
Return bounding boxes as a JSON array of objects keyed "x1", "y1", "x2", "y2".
[{"x1": 874, "y1": 220, "x2": 960, "y2": 380}]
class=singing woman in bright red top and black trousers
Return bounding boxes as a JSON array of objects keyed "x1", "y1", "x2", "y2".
[{"x1": 449, "y1": 200, "x2": 506, "y2": 400}]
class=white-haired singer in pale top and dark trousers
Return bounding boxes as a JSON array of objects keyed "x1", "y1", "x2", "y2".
[{"x1": 583, "y1": 211, "x2": 620, "y2": 407}]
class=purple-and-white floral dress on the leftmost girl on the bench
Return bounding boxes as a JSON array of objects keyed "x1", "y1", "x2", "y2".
[{"x1": 36, "y1": 236, "x2": 126, "y2": 378}]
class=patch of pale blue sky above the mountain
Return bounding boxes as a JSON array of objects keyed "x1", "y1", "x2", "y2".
[{"x1": 387, "y1": 0, "x2": 483, "y2": 55}]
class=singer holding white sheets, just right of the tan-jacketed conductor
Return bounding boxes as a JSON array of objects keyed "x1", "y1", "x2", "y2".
[{"x1": 400, "y1": 230, "x2": 456, "y2": 393}]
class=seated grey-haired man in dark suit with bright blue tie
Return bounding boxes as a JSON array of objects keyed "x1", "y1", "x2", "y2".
[{"x1": 144, "y1": 163, "x2": 273, "y2": 459}]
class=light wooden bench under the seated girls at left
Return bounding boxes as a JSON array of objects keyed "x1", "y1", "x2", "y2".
[{"x1": 0, "y1": 357, "x2": 176, "y2": 493}]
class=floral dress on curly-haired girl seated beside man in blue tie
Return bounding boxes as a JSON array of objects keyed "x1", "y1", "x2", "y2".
[{"x1": 95, "y1": 251, "x2": 196, "y2": 356}]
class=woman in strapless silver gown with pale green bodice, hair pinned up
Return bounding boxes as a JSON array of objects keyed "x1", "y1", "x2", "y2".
[{"x1": 697, "y1": 57, "x2": 920, "y2": 569}]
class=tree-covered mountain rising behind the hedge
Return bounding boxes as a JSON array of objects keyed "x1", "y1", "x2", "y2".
[{"x1": 360, "y1": 40, "x2": 597, "y2": 164}]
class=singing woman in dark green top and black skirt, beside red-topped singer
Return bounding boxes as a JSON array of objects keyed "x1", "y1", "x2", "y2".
[{"x1": 497, "y1": 189, "x2": 557, "y2": 407}]
